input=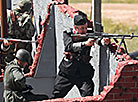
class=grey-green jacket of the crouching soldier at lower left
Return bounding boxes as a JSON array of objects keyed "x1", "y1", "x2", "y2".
[{"x1": 3, "y1": 60, "x2": 27, "y2": 102}]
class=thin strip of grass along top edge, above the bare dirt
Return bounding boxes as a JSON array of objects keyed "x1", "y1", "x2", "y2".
[{"x1": 69, "y1": 0, "x2": 138, "y2": 3}]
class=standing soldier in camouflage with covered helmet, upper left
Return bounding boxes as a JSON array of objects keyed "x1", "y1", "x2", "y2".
[{"x1": 7, "y1": 0, "x2": 35, "y2": 53}]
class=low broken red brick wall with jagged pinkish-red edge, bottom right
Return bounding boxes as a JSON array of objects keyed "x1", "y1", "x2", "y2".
[{"x1": 37, "y1": 60, "x2": 138, "y2": 102}]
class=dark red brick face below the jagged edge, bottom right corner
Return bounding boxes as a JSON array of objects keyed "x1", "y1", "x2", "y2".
[{"x1": 103, "y1": 65, "x2": 138, "y2": 102}]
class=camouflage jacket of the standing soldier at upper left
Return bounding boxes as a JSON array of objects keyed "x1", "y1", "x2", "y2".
[{"x1": 7, "y1": 9, "x2": 35, "y2": 52}]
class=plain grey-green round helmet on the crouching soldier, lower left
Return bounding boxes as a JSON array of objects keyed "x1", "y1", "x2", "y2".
[{"x1": 16, "y1": 49, "x2": 30, "y2": 63}]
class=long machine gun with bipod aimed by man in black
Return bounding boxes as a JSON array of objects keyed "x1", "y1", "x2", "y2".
[{"x1": 71, "y1": 32, "x2": 138, "y2": 56}]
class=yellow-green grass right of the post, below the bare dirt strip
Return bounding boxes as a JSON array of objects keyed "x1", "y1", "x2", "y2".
[{"x1": 103, "y1": 19, "x2": 138, "y2": 53}]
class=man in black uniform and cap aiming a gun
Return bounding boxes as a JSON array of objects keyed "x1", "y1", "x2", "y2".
[{"x1": 52, "y1": 15, "x2": 109, "y2": 98}]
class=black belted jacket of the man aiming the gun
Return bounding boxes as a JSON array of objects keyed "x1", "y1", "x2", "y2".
[{"x1": 59, "y1": 29, "x2": 94, "y2": 77}]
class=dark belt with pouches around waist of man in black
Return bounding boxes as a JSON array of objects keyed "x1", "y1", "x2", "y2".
[{"x1": 64, "y1": 52, "x2": 92, "y2": 63}]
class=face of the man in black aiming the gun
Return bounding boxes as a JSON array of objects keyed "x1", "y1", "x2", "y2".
[{"x1": 74, "y1": 23, "x2": 87, "y2": 34}]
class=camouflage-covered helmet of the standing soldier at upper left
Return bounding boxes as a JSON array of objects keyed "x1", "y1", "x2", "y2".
[{"x1": 18, "y1": 0, "x2": 32, "y2": 12}]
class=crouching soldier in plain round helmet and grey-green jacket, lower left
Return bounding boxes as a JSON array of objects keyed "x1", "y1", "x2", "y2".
[{"x1": 3, "y1": 49, "x2": 48, "y2": 102}]
